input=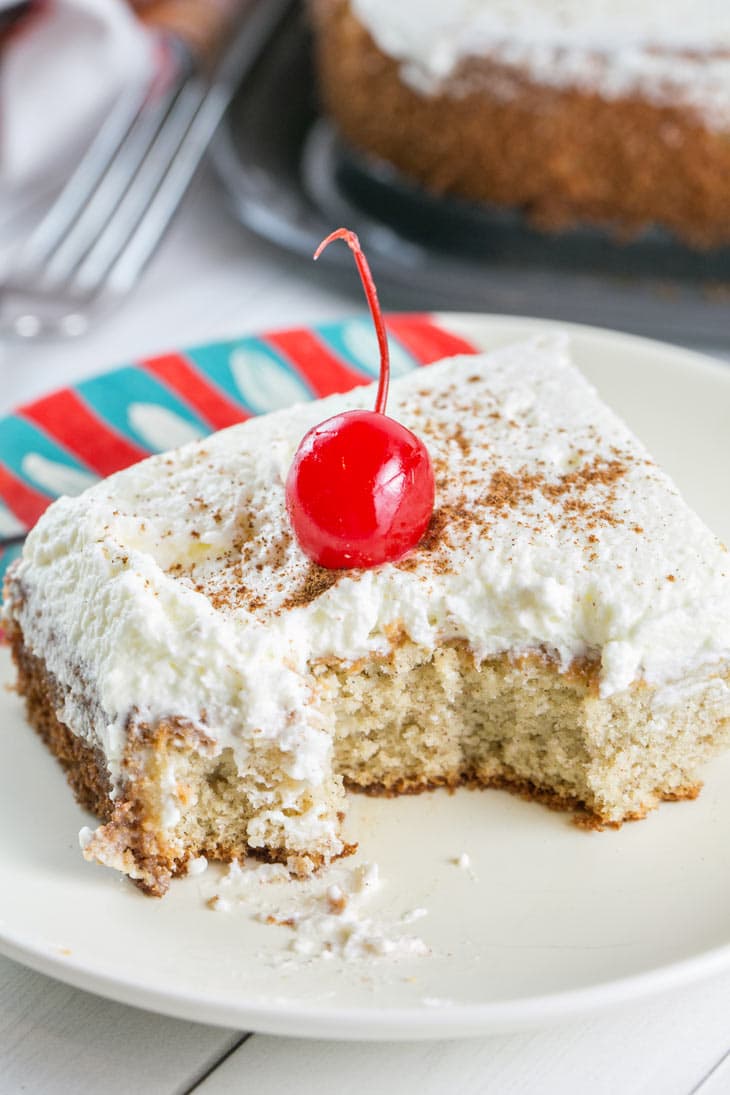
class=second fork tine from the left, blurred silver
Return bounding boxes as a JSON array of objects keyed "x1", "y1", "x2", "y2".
[{"x1": 42, "y1": 67, "x2": 186, "y2": 283}]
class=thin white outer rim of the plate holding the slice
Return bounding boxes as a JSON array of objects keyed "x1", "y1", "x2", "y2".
[{"x1": 0, "y1": 311, "x2": 730, "y2": 1041}]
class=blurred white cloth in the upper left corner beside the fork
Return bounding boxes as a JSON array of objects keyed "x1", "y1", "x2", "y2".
[{"x1": 0, "y1": 0, "x2": 154, "y2": 221}]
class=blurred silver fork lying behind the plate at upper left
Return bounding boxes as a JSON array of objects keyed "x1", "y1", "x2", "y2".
[{"x1": 0, "y1": 0, "x2": 292, "y2": 339}]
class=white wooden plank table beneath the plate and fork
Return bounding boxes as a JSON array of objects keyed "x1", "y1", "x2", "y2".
[{"x1": 0, "y1": 170, "x2": 730, "y2": 1095}]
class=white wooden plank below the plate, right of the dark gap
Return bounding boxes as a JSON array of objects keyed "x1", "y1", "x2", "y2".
[{"x1": 196, "y1": 975, "x2": 730, "y2": 1095}]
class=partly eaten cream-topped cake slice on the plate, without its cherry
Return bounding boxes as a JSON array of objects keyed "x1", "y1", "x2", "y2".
[{"x1": 5, "y1": 336, "x2": 730, "y2": 894}]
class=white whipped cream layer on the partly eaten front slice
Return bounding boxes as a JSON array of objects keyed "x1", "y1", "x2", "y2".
[{"x1": 9, "y1": 336, "x2": 730, "y2": 805}]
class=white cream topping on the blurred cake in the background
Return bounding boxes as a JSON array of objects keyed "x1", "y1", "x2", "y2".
[{"x1": 350, "y1": 0, "x2": 730, "y2": 128}]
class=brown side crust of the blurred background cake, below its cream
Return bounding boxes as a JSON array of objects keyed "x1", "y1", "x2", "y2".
[{"x1": 311, "y1": 0, "x2": 730, "y2": 246}]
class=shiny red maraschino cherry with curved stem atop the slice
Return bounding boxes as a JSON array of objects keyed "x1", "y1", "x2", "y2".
[{"x1": 287, "y1": 228, "x2": 434, "y2": 569}]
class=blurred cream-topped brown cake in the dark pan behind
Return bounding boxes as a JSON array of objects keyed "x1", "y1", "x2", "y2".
[{"x1": 311, "y1": 0, "x2": 730, "y2": 246}]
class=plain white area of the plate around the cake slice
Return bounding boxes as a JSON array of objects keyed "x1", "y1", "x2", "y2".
[{"x1": 0, "y1": 316, "x2": 730, "y2": 1039}]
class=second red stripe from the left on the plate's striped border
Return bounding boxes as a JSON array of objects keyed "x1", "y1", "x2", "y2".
[{"x1": 19, "y1": 388, "x2": 149, "y2": 475}]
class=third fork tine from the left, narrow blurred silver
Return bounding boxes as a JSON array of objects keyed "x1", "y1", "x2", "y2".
[{"x1": 72, "y1": 80, "x2": 209, "y2": 292}]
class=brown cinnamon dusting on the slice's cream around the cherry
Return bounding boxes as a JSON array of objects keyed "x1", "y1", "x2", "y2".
[{"x1": 153, "y1": 374, "x2": 639, "y2": 615}]
